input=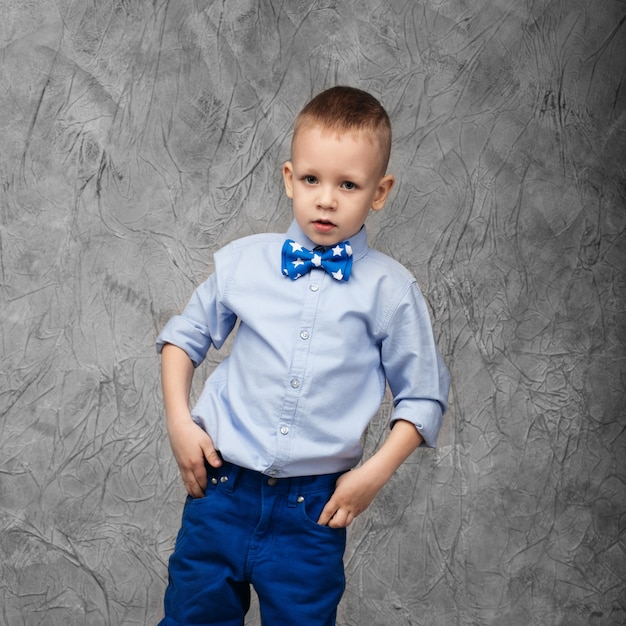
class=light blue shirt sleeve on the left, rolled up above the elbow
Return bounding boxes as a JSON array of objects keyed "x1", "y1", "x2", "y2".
[{"x1": 156, "y1": 274, "x2": 237, "y2": 367}]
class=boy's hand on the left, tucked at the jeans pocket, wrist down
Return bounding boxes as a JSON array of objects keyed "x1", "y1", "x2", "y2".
[{"x1": 167, "y1": 417, "x2": 222, "y2": 498}]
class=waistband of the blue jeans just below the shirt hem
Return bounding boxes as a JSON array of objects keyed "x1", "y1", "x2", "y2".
[{"x1": 206, "y1": 461, "x2": 345, "y2": 504}]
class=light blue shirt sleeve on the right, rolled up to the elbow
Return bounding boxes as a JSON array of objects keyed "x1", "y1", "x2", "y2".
[{"x1": 382, "y1": 284, "x2": 450, "y2": 448}]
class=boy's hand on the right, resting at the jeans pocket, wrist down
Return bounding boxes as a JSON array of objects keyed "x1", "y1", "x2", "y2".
[{"x1": 317, "y1": 466, "x2": 382, "y2": 528}]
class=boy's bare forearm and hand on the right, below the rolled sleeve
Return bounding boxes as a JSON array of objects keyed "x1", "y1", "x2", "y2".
[{"x1": 317, "y1": 419, "x2": 423, "y2": 528}]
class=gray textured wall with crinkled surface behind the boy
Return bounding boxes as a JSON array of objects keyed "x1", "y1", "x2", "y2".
[{"x1": 0, "y1": 0, "x2": 626, "y2": 626}]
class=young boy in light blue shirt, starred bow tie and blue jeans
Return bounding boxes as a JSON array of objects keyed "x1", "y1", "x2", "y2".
[{"x1": 158, "y1": 87, "x2": 450, "y2": 626}]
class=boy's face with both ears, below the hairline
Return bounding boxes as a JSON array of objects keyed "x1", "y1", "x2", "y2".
[{"x1": 283, "y1": 125, "x2": 394, "y2": 246}]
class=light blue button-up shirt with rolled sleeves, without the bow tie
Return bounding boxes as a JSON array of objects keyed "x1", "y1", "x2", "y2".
[{"x1": 157, "y1": 222, "x2": 450, "y2": 477}]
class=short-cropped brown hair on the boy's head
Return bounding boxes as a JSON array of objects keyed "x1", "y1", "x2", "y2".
[{"x1": 292, "y1": 85, "x2": 391, "y2": 174}]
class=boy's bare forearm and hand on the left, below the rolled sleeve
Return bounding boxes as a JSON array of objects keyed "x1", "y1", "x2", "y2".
[{"x1": 161, "y1": 343, "x2": 222, "y2": 498}]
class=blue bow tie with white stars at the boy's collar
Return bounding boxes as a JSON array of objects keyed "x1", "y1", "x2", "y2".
[{"x1": 283, "y1": 239, "x2": 352, "y2": 280}]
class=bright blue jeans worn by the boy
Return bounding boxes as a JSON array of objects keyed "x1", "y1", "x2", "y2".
[{"x1": 160, "y1": 462, "x2": 346, "y2": 626}]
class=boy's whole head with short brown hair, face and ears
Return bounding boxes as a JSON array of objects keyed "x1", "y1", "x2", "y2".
[{"x1": 283, "y1": 87, "x2": 394, "y2": 245}]
